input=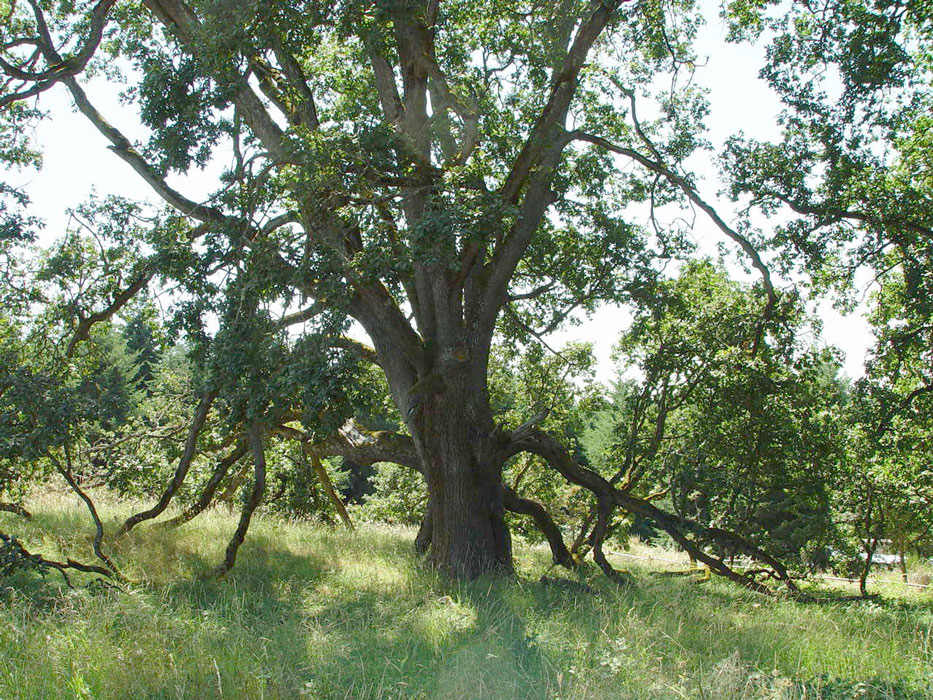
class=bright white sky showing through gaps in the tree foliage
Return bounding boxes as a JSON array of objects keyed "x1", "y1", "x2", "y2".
[{"x1": 14, "y1": 1, "x2": 872, "y2": 381}]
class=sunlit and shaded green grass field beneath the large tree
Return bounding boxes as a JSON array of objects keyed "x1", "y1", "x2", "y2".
[{"x1": 0, "y1": 496, "x2": 933, "y2": 700}]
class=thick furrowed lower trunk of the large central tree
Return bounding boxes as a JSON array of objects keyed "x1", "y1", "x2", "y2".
[{"x1": 413, "y1": 390, "x2": 512, "y2": 579}]
